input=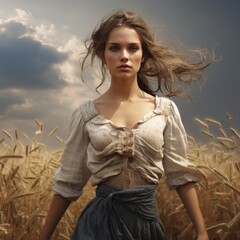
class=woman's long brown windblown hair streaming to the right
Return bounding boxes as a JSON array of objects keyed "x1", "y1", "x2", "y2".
[{"x1": 81, "y1": 10, "x2": 214, "y2": 97}]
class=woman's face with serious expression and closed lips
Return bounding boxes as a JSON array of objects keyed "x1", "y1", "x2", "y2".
[{"x1": 104, "y1": 26, "x2": 143, "y2": 79}]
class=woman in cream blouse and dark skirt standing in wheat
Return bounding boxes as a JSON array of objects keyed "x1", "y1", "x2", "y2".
[{"x1": 40, "y1": 10, "x2": 210, "y2": 240}]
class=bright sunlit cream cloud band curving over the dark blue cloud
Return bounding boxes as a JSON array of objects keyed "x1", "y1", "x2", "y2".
[{"x1": 0, "y1": 8, "x2": 99, "y2": 89}]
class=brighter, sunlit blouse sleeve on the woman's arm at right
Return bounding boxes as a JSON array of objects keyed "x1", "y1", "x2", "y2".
[{"x1": 163, "y1": 101, "x2": 203, "y2": 189}]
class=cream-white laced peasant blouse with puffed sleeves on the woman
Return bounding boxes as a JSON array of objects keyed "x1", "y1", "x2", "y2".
[{"x1": 53, "y1": 97, "x2": 203, "y2": 200}]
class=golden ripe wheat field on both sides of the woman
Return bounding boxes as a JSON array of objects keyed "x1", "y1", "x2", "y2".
[{"x1": 0, "y1": 118, "x2": 240, "y2": 240}]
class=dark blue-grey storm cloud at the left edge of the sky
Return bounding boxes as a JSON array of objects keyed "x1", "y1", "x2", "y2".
[{"x1": 0, "y1": 22, "x2": 67, "y2": 89}]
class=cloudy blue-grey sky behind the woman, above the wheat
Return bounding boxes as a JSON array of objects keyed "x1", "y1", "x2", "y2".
[{"x1": 0, "y1": 0, "x2": 240, "y2": 150}]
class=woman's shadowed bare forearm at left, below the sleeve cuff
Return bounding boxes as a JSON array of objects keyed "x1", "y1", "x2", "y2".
[{"x1": 40, "y1": 194, "x2": 71, "y2": 240}]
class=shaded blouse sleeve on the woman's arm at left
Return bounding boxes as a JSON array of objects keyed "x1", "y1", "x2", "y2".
[{"x1": 52, "y1": 108, "x2": 91, "y2": 201}]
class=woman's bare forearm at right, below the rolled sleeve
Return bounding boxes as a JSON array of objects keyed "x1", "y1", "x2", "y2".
[{"x1": 177, "y1": 183, "x2": 208, "y2": 240}]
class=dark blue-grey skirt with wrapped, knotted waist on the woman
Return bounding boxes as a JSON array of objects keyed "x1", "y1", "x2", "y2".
[{"x1": 72, "y1": 184, "x2": 167, "y2": 240}]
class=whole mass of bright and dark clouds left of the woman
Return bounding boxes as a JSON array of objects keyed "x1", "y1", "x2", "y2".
[{"x1": 0, "y1": 9, "x2": 97, "y2": 147}]
